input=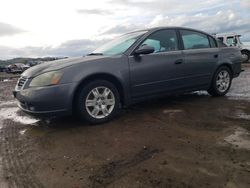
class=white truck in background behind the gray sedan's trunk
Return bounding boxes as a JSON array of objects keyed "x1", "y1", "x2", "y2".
[{"x1": 215, "y1": 33, "x2": 250, "y2": 63}]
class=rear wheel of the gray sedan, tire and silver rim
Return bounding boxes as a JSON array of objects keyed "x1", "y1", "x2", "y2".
[{"x1": 207, "y1": 66, "x2": 232, "y2": 97}]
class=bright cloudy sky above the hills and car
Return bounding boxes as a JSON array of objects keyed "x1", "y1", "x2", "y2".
[{"x1": 0, "y1": 0, "x2": 250, "y2": 59}]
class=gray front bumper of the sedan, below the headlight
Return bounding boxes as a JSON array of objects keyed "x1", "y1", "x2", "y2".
[{"x1": 13, "y1": 83, "x2": 77, "y2": 116}]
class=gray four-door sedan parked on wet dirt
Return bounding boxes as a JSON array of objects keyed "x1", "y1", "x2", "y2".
[{"x1": 13, "y1": 27, "x2": 242, "y2": 123}]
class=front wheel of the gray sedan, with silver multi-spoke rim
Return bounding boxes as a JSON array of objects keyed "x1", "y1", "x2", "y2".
[{"x1": 76, "y1": 80, "x2": 120, "y2": 124}]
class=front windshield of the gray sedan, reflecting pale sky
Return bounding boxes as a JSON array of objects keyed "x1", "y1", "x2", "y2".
[{"x1": 90, "y1": 31, "x2": 147, "y2": 55}]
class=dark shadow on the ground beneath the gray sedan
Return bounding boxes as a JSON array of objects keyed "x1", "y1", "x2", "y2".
[{"x1": 31, "y1": 92, "x2": 211, "y2": 129}]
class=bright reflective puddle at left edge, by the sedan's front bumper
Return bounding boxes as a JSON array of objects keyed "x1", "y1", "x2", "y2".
[{"x1": 0, "y1": 107, "x2": 39, "y2": 125}]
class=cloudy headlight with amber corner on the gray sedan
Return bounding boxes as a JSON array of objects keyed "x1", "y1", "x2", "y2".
[{"x1": 29, "y1": 71, "x2": 62, "y2": 87}]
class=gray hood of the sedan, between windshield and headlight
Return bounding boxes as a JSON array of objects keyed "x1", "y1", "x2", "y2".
[{"x1": 22, "y1": 56, "x2": 107, "y2": 78}]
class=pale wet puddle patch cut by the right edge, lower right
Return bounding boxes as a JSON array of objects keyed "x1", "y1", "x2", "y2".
[{"x1": 224, "y1": 127, "x2": 250, "y2": 150}]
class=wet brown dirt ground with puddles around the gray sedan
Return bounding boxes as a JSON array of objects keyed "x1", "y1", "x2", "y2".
[{"x1": 0, "y1": 66, "x2": 250, "y2": 188}]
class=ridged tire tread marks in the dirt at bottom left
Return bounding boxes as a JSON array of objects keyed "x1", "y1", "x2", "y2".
[{"x1": 0, "y1": 120, "x2": 43, "y2": 188}]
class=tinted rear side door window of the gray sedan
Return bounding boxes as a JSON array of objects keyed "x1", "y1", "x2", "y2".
[{"x1": 180, "y1": 30, "x2": 210, "y2": 50}]
